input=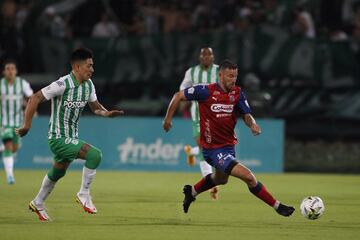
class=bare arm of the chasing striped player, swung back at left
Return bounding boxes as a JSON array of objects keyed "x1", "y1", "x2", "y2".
[{"x1": 15, "y1": 90, "x2": 46, "y2": 137}]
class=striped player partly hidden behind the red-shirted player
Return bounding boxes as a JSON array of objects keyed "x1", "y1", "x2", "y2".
[{"x1": 180, "y1": 47, "x2": 219, "y2": 200}]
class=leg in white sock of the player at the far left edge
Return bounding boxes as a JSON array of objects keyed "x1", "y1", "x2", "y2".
[{"x1": 2, "y1": 128, "x2": 15, "y2": 184}]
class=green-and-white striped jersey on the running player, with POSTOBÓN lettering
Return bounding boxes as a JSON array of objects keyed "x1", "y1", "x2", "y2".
[{"x1": 41, "y1": 73, "x2": 97, "y2": 139}]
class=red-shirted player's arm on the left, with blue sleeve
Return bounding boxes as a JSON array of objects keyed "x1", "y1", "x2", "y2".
[{"x1": 163, "y1": 85, "x2": 210, "y2": 132}]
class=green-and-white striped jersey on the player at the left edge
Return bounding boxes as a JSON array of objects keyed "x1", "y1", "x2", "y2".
[{"x1": 0, "y1": 77, "x2": 33, "y2": 128}]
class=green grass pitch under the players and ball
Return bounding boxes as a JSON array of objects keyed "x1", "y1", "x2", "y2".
[{"x1": 0, "y1": 170, "x2": 360, "y2": 240}]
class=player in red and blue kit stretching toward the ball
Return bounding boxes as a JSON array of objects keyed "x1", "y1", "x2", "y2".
[{"x1": 163, "y1": 60, "x2": 295, "y2": 216}]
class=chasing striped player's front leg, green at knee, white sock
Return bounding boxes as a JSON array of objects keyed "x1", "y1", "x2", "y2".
[{"x1": 76, "y1": 143, "x2": 102, "y2": 214}]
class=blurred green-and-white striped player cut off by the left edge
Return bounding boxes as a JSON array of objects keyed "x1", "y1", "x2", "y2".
[{"x1": 0, "y1": 60, "x2": 33, "y2": 184}]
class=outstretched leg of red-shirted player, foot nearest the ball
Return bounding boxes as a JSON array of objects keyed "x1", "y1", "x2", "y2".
[{"x1": 231, "y1": 163, "x2": 295, "y2": 216}]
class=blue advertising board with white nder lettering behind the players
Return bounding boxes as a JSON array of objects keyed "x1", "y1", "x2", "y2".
[{"x1": 16, "y1": 117, "x2": 284, "y2": 172}]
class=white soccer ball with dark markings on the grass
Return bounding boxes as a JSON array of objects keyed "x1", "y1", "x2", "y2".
[{"x1": 300, "y1": 196, "x2": 325, "y2": 220}]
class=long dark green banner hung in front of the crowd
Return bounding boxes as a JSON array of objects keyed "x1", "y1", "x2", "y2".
[{"x1": 31, "y1": 24, "x2": 360, "y2": 88}]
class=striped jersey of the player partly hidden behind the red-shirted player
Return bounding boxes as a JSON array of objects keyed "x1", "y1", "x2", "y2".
[{"x1": 180, "y1": 64, "x2": 219, "y2": 123}]
